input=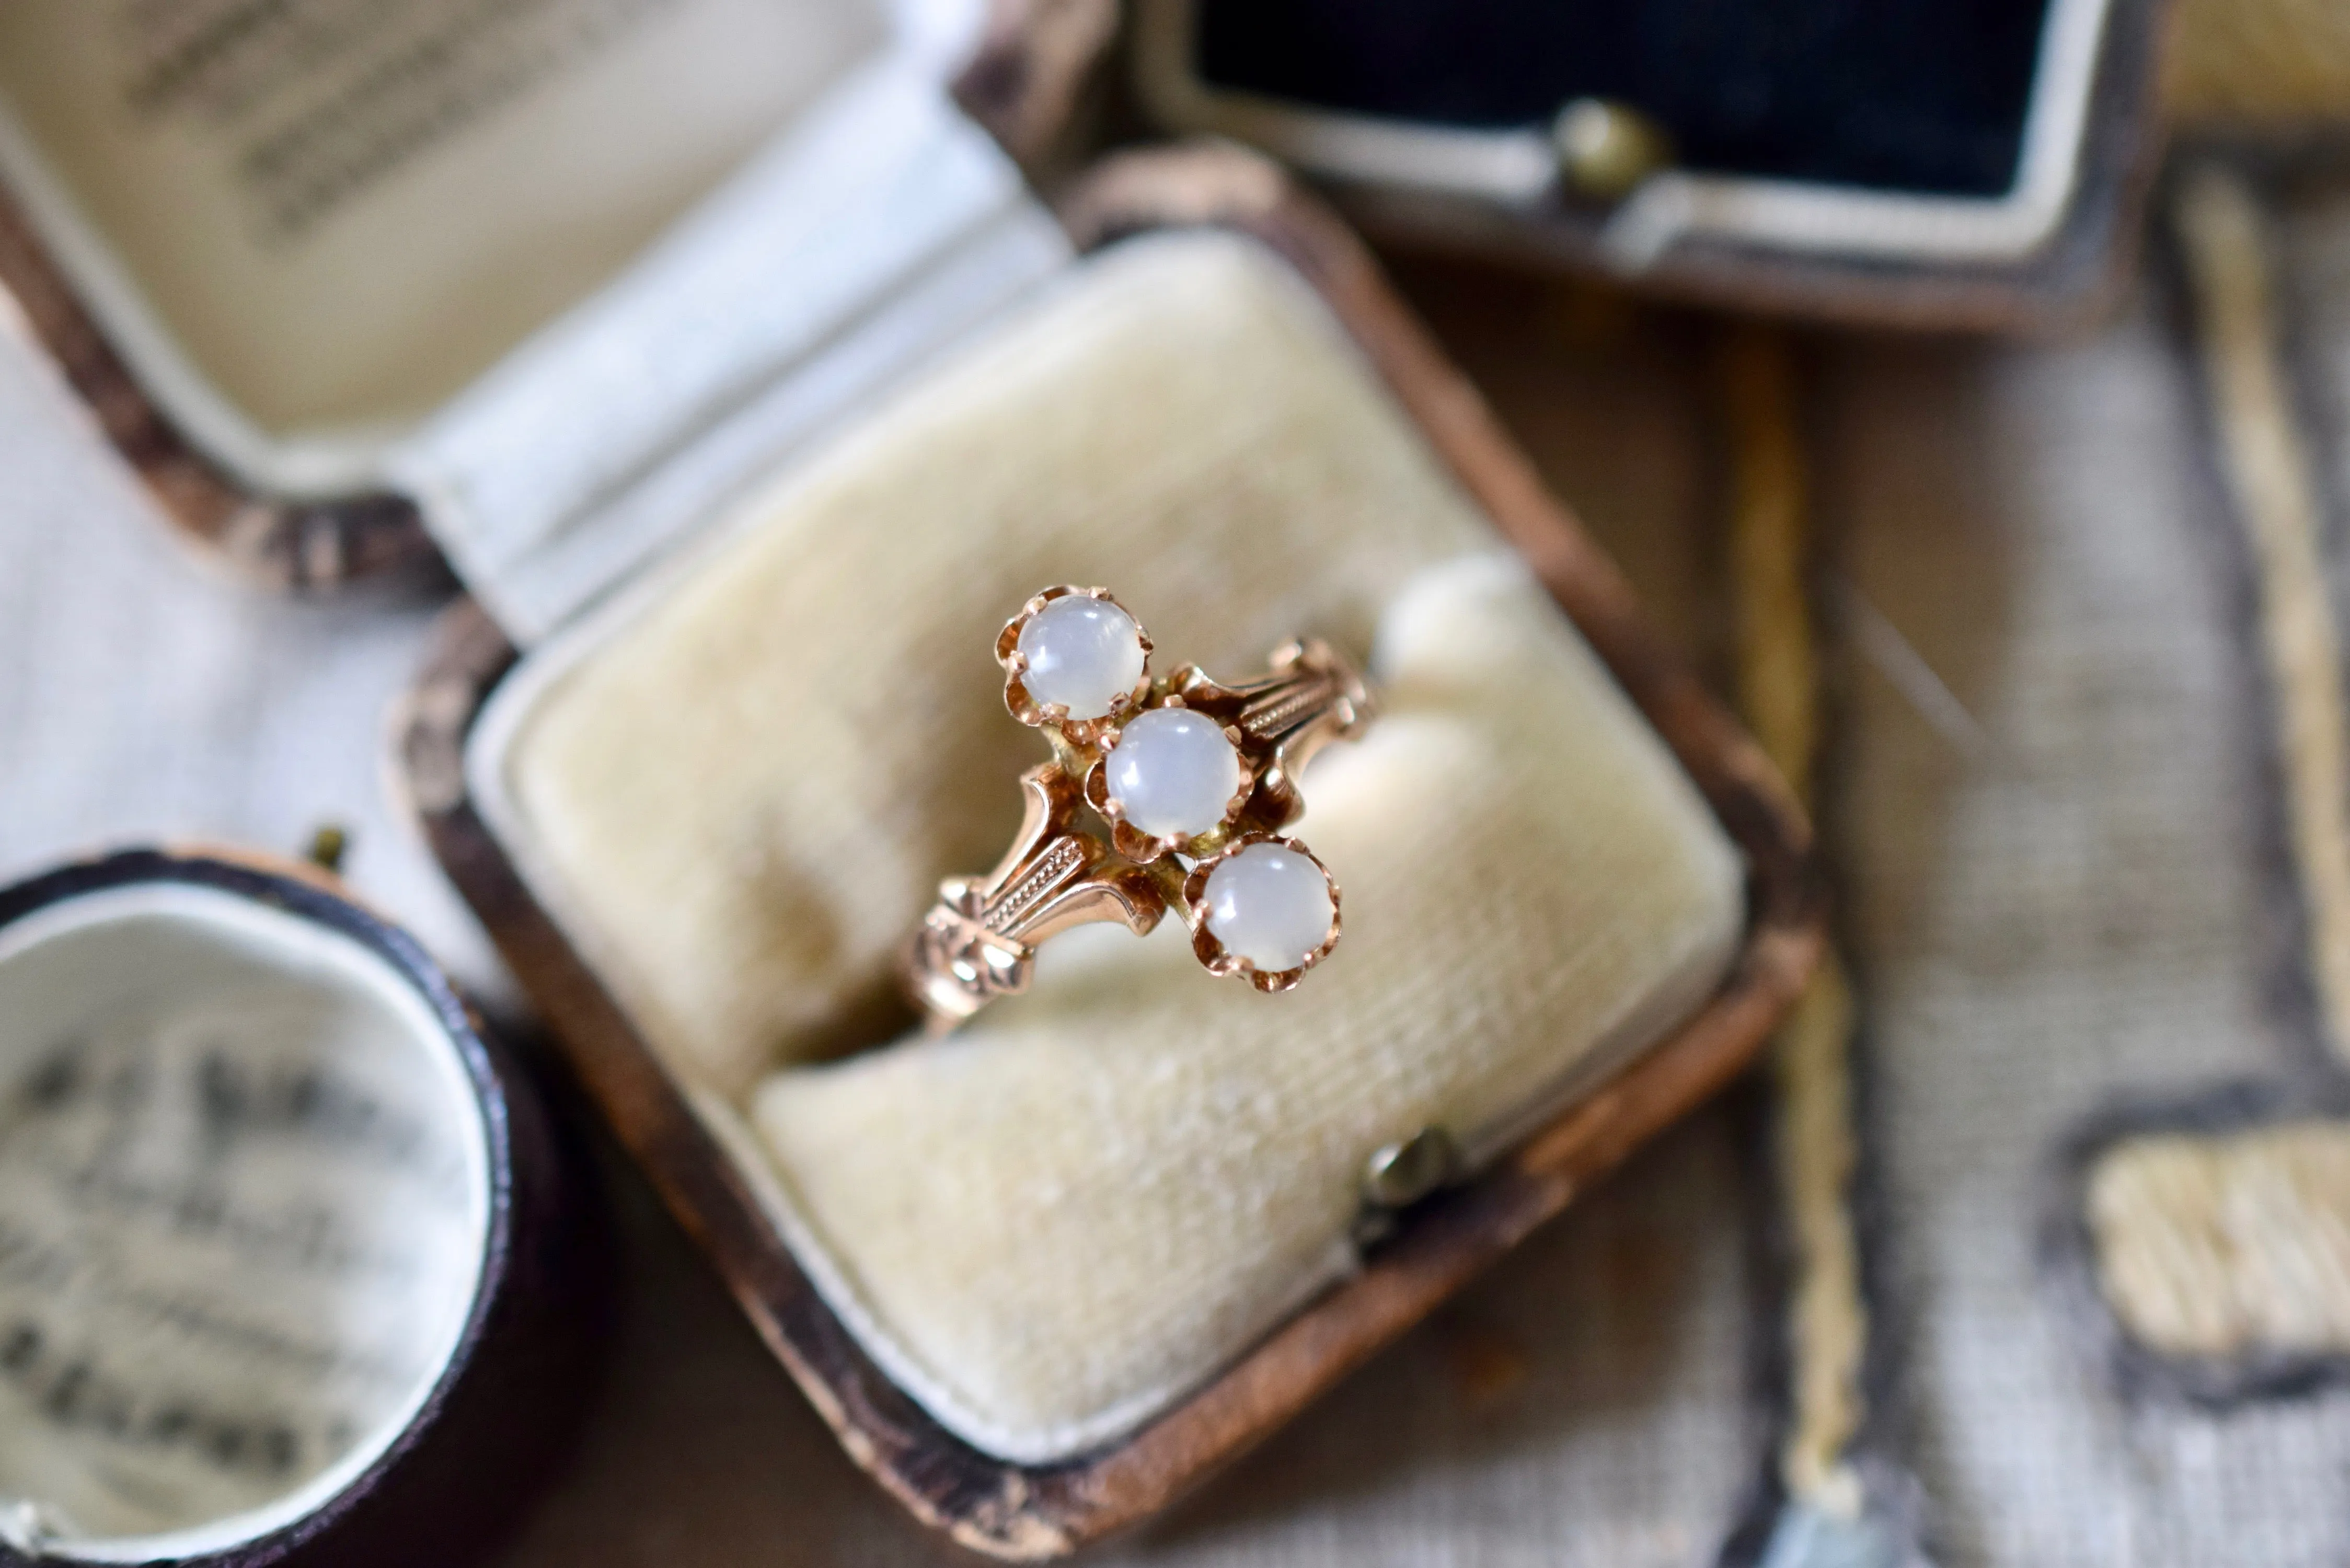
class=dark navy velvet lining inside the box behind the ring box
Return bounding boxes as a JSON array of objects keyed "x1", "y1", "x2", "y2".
[{"x1": 1196, "y1": 0, "x2": 2049, "y2": 195}]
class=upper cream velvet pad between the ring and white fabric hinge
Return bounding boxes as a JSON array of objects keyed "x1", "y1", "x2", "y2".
[{"x1": 489, "y1": 240, "x2": 1492, "y2": 1096}]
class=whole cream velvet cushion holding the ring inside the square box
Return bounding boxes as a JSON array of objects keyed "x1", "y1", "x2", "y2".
[{"x1": 468, "y1": 233, "x2": 1744, "y2": 1462}]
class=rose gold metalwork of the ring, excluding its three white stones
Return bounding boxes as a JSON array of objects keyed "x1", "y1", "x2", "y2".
[{"x1": 902, "y1": 585, "x2": 1377, "y2": 1034}]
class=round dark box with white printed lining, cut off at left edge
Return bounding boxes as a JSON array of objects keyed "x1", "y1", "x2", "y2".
[{"x1": 0, "y1": 849, "x2": 604, "y2": 1568}]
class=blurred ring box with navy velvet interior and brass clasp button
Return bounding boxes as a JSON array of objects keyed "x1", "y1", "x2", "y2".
[{"x1": 1133, "y1": 0, "x2": 2162, "y2": 329}]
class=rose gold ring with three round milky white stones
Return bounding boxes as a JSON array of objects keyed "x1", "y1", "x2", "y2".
[{"x1": 905, "y1": 587, "x2": 1373, "y2": 1032}]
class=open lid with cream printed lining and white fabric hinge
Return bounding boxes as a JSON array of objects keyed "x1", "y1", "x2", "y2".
[{"x1": 0, "y1": 0, "x2": 1107, "y2": 620}]
